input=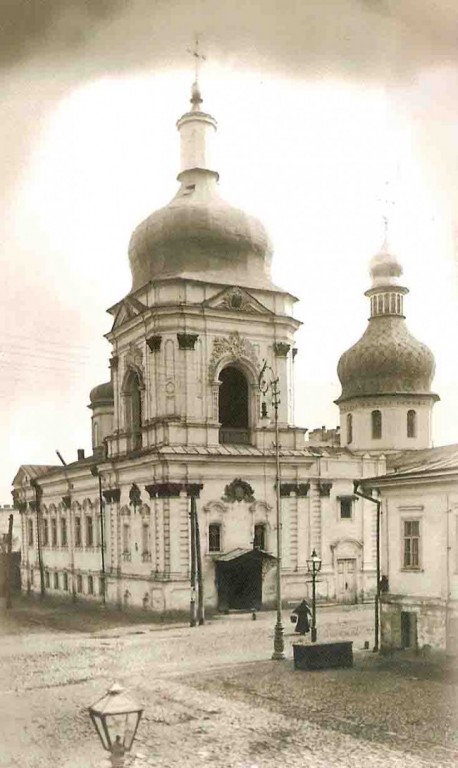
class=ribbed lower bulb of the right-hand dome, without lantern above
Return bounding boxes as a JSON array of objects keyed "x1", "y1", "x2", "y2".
[{"x1": 336, "y1": 315, "x2": 435, "y2": 403}]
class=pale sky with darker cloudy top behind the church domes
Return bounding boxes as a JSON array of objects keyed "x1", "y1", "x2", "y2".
[{"x1": 0, "y1": 0, "x2": 458, "y2": 504}]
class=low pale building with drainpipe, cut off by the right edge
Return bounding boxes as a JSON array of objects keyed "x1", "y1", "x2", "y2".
[{"x1": 361, "y1": 445, "x2": 458, "y2": 654}]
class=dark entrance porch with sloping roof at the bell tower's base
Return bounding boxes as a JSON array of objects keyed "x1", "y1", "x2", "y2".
[{"x1": 215, "y1": 548, "x2": 276, "y2": 611}]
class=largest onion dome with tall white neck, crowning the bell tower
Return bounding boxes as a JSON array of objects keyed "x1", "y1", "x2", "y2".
[{"x1": 129, "y1": 83, "x2": 272, "y2": 291}]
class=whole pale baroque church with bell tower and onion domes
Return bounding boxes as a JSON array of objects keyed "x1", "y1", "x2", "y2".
[{"x1": 13, "y1": 84, "x2": 435, "y2": 611}]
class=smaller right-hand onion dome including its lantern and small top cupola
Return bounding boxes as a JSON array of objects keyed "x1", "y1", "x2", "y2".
[{"x1": 336, "y1": 246, "x2": 438, "y2": 403}]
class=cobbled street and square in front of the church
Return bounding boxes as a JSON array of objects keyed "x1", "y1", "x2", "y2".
[{"x1": 0, "y1": 606, "x2": 458, "y2": 768}]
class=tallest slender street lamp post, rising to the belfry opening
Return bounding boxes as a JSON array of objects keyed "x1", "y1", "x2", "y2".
[{"x1": 259, "y1": 360, "x2": 286, "y2": 660}]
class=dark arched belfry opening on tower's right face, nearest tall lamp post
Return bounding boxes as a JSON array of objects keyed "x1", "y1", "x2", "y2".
[{"x1": 218, "y1": 365, "x2": 250, "y2": 444}]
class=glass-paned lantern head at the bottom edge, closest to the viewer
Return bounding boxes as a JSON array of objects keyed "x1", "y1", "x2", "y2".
[{"x1": 89, "y1": 683, "x2": 143, "y2": 766}]
